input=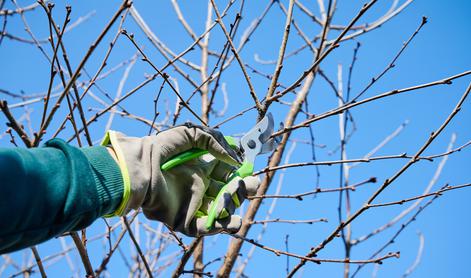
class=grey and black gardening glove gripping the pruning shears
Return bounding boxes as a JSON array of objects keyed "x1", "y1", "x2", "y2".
[{"x1": 103, "y1": 124, "x2": 260, "y2": 236}]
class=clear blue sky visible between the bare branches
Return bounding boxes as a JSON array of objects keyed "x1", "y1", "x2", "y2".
[{"x1": 0, "y1": 0, "x2": 471, "y2": 277}]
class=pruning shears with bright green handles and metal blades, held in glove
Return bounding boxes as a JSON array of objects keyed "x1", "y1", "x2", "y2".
[{"x1": 161, "y1": 113, "x2": 277, "y2": 229}]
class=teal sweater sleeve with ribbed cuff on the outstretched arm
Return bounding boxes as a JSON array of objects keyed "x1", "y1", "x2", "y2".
[{"x1": 0, "y1": 139, "x2": 123, "y2": 254}]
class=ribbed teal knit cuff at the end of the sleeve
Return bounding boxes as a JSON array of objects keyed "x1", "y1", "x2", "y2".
[{"x1": 80, "y1": 146, "x2": 124, "y2": 216}]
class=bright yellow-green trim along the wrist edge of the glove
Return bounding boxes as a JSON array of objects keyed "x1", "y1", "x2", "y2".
[{"x1": 101, "y1": 130, "x2": 131, "y2": 217}]
